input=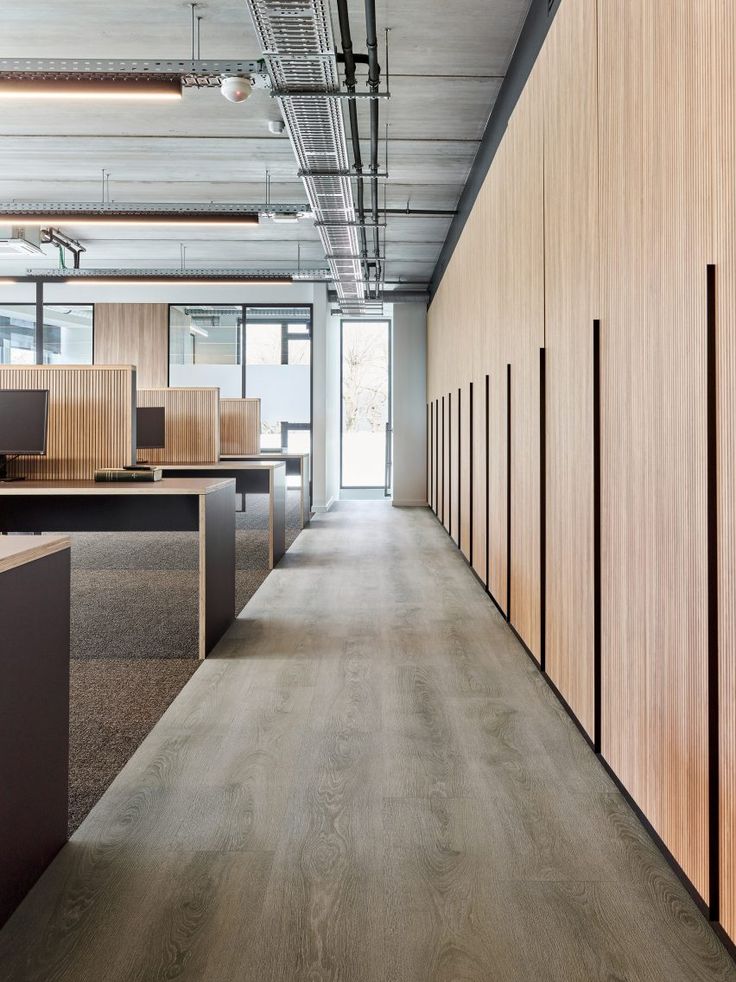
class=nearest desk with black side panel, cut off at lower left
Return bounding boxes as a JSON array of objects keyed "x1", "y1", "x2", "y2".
[{"x1": 0, "y1": 535, "x2": 70, "y2": 925}]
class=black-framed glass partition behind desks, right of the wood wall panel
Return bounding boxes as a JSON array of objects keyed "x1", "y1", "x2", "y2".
[{"x1": 169, "y1": 304, "x2": 312, "y2": 464}]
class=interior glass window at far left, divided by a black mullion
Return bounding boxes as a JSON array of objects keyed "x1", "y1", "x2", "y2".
[{"x1": 0, "y1": 304, "x2": 94, "y2": 365}]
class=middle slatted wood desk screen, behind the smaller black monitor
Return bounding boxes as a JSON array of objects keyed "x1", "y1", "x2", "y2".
[{"x1": 138, "y1": 388, "x2": 220, "y2": 464}]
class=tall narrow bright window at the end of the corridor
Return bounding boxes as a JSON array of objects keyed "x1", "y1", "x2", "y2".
[{"x1": 340, "y1": 321, "x2": 391, "y2": 488}]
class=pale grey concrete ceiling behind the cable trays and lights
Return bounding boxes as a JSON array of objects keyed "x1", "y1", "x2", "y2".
[{"x1": 0, "y1": 0, "x2": 529, "y2": 292}]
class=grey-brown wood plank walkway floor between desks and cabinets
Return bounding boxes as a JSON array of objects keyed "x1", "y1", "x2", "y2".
[{"x1": 0, "y1": 502, "x2": 736, "y2": 982}]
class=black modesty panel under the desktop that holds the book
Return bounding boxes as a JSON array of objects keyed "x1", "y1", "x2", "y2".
[{"x1": 0, "y1": 494, "x2": 199, "y2": 532}]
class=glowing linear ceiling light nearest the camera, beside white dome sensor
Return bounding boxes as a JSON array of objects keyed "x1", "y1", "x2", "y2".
[{"x1": 0, "y1": 73, "x2": 181, "y2": 101}]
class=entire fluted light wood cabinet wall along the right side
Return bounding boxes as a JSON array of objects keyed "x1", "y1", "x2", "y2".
[{"x1": 428, "y1": 0, "x2": 736, "y2": 939}]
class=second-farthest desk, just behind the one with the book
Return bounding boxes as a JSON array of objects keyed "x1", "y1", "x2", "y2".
[{"x1": 159, "y1": 460, "x2": 286, "y2": 569}]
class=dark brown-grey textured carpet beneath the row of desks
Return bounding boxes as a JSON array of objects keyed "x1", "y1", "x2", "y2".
[{"x1": 64, "y1": 492, "x2": 300, "y2": 833}]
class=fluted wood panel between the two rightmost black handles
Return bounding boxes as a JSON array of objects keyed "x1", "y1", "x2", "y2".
[{"x1": 598, "y1": 0, "x2": 713, "y2": 901}]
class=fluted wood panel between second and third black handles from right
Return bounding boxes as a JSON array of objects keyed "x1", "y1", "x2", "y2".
[{"x1": 542, "y1": 2, "x2": 599, "y2": 738}]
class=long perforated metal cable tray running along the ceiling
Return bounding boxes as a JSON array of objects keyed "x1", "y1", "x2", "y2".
[{"x1": 246, "y1": 0, "x2": 365, "y2": 302}]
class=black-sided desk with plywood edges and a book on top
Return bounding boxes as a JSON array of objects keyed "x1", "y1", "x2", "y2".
[{"x1": 0, "y1": 478, "x2": 235, "y2": 658}]
